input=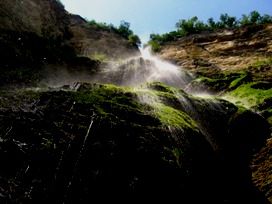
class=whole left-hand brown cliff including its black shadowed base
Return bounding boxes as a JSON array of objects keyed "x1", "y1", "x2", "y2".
[{"x1": 0, "y1": 0, "x2": 139, "y2": 85}]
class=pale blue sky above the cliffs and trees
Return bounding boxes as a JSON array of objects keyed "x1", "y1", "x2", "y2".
[{"x1": 61, "y1": 0, "x2": 272, "y2": 43}]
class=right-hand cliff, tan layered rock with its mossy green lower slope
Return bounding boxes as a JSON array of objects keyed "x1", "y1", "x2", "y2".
[{"x1": 157, "y1": 24, "x2": 272, "y2": 202}]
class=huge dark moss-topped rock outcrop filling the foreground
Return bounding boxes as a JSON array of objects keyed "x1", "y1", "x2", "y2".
[{"x1": 0, "y1": 83, "x2": 269, "y2": 204}]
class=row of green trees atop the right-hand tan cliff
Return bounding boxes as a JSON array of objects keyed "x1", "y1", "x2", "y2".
[{"x1": 147, "y1": 11, "x2": 272, "y2": 52}]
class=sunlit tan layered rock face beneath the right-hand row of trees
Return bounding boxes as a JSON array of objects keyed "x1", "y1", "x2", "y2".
[{"x1": 158, "y1": 25, "x2": 272, "y2": 71}]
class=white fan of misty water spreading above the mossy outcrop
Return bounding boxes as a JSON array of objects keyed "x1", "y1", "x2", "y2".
[{"x1": 94, "y1": 47, "x2": 194, "y2": 88}]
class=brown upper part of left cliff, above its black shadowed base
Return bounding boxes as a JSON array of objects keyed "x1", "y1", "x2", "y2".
[{"x1": 0, "y1": 0, "x2": 138, "y2": 59}]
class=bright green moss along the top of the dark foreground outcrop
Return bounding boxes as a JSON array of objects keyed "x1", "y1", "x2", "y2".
[{"x1": 2, "y1": 83, "x2": 202, "y2": 135}]
